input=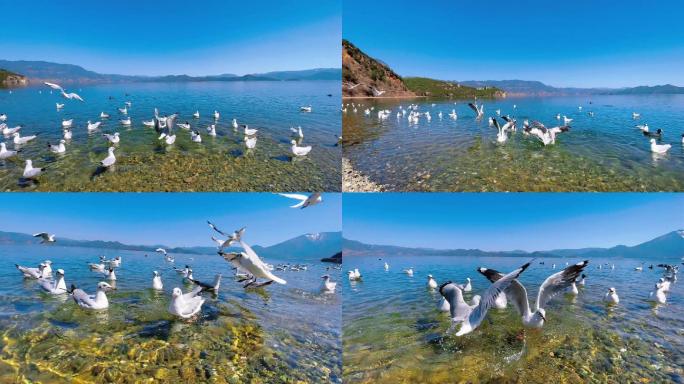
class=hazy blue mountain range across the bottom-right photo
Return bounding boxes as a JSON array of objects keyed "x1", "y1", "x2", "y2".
[{"x1": 343, "y1": 230, "x2": 684, "y2": 259}]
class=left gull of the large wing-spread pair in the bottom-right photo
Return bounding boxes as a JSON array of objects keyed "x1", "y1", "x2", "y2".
[{"x1": 439, "y1": 263, "x2": 530, "y2": 336}]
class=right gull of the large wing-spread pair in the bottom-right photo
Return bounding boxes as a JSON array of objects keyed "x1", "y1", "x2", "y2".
[{"x1": 478, "y1": 260, "x2": 589, "y2": 328}]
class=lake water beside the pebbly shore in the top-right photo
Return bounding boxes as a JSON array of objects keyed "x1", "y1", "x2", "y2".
[{"x1": 343, "y1": 95, "x2": 684, "y2": 191}]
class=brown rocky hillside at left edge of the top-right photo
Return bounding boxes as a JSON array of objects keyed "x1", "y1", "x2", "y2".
[{"x1": 342, "y1": 40, "x2": 416, "y2": 97}]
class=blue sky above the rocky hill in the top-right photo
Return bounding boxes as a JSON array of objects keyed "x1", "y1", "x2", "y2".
[{"x1": 343, "y1": 0, "x2": 684, "y2": 87}]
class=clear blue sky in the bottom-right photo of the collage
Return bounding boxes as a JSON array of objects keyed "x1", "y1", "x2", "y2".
[{"x1": 343, "y1": 193, "x2": 684, "y2": 251}]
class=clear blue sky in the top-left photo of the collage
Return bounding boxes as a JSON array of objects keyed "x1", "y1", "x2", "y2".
[{"x1": 0, "y1": 0, "x2": 342, "y2": 75}]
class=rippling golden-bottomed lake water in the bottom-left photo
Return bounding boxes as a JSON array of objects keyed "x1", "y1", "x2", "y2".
[{"x1": 0, "y1": 245, "x2": 342, "y2": 383}]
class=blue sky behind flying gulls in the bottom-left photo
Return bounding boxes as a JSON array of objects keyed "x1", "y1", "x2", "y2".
[{"x1": 0, "y1": 193, "x2": 342, "y2": 246}]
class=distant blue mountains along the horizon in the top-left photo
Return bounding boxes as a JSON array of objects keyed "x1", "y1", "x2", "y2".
[{"x1": 0, "y1": 60, "x2": 342, "y2": 84}]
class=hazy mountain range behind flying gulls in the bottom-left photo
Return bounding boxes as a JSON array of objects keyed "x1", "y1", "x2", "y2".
[{"x1": 0, "y1": 231, "x2": 342, "y2": 261}]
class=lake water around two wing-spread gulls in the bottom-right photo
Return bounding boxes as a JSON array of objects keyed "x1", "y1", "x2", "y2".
[{"x1": 342, "y1": 256, "x2": 684, "y2": 383}]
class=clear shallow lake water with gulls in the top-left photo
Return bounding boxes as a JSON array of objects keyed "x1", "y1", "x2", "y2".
[{"x1": 0, "y1": 81, "x2": 341, "y2": 191}]
